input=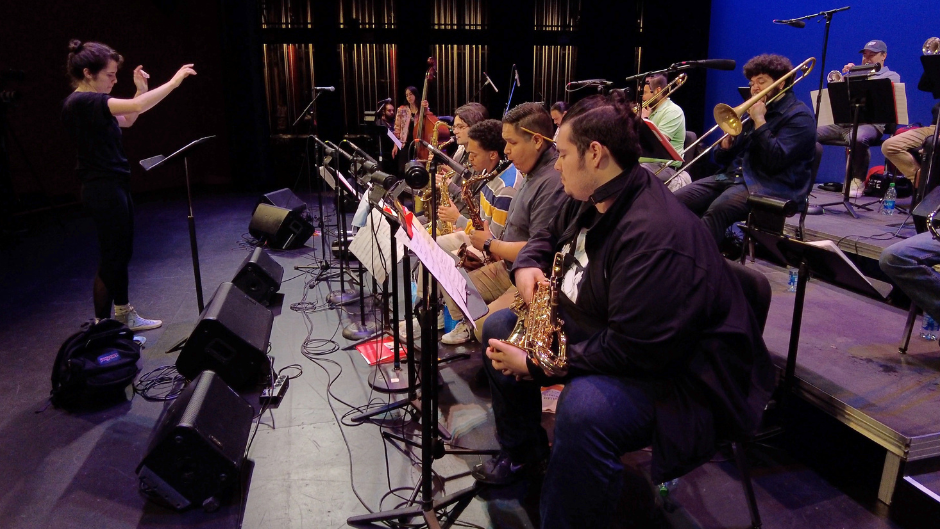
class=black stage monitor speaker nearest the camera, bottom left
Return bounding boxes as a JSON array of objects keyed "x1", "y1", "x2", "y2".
[{"x1": 137, "y1": 371, "x2": 255, "y2": 512}]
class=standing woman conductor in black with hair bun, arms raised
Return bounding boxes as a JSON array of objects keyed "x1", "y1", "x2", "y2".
[{"x1": 62, "y1": 40, "x2": 196, "y2": 330}]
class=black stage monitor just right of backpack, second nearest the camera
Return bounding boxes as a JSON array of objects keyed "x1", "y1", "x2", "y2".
[{"x1": 176, "y1": 283, "x2": 274, "y2": 390}]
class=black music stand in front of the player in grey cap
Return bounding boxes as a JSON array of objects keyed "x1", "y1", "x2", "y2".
[{"x1": 817, "y1": 76, "x2": 898, "y2": 219}]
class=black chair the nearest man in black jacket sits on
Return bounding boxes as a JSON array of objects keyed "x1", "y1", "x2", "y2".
[{"x1": 726, "y1": 261, "x2": 772, "y2": 529}]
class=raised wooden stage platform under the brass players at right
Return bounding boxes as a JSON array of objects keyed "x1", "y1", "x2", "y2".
[{"x1": 748, "y1": 184, "x2": 940, "y2": 504}]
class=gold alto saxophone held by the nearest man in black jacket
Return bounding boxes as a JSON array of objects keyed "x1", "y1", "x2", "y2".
[{"x1": 506, "y1": 252, "x2": 568, "y2": 376}]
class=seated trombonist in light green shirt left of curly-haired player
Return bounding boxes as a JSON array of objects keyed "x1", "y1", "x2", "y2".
[{"x1": 640, "y1": 74, "x2": 692, "y2": 191}]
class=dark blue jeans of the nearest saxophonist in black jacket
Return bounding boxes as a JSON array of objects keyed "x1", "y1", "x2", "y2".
[{"x1": 483, "y1": 310, "x2": 654, "y2": 529}]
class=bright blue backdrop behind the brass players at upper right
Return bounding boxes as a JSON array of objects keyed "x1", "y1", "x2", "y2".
[{"x1": 705, "y1": 0, "x2": 940, "y2": 182}]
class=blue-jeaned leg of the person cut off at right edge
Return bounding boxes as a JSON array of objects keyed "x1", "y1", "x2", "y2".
[{"x1": 878, "y1": 232, "x2": 940, "y2": 321}]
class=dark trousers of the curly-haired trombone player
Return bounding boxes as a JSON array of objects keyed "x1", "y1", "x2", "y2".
[{"x1": 675, "y1": 174, "x2": 750, "y2": 243}]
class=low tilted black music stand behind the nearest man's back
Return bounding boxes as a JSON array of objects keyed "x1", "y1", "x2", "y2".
[{"x1": 744, "y1": 226, "x2": 885, "y2": 390}]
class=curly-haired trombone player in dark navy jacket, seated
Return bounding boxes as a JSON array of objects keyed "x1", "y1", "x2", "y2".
[{"x1": 676, "y1": 54, "x2": 816, "y2": 243}]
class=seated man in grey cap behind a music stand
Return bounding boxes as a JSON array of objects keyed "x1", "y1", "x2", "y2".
[{"x1": 815, "y1": 40, "x2": 901, "y2": 193}]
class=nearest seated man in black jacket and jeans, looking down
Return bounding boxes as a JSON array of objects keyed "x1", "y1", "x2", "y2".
[{"x1": 472, "y1": 88, "x2": 774, "y2": 528}]
